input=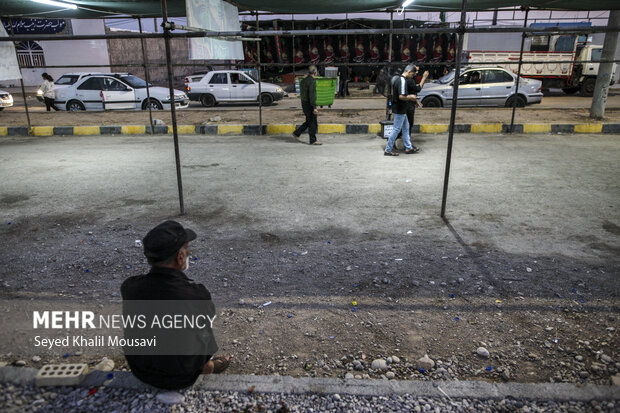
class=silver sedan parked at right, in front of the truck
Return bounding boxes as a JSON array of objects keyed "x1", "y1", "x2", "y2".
[{"x1": 418, "y1": 67, "x2": 543, "y2": 108}]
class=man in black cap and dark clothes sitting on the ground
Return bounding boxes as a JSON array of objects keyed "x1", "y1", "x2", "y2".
[{"x1": 121, "y1": 221, "x2": 230, "y2": 390}]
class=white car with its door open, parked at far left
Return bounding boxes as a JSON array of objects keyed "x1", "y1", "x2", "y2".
[{"x1": 55, "y1": 73, "x2": 189, "y2": 111}]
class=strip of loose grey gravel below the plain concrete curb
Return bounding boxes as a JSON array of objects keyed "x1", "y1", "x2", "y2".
[{"x1": 0, "y1": 383, "x2": 617, "y2": 413}]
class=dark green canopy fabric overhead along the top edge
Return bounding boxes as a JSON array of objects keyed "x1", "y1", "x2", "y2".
[{"x1": 0, "y1": 0, "x2": 620, "y2": 19}]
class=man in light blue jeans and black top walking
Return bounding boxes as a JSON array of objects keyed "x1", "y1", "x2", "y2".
[{"x1": 383, "y1": 64, "x2": 418, "y2": 156}]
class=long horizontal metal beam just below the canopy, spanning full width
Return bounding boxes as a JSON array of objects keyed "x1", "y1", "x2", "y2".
[{"x1": 0, "y1": 26, "x2": 618, "y2": 42}]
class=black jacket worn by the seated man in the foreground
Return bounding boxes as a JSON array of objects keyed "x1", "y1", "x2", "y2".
[{"x1": 121, "y1": 267, "x2": 217, "y2": 389}]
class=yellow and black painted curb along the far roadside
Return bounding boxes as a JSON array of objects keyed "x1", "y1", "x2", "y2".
[{"x1": 0, "y1": 123, "x2": 620, "y2": 136}]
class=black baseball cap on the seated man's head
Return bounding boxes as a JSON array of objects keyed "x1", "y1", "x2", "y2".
[{"x1": 142, "y1": 221, "x2": 196, "y2": 262}]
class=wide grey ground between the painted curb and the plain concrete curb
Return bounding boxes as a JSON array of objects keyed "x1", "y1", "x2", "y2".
[{"x1": 0, "y1": 134, "x2": 620, "y2": 408}]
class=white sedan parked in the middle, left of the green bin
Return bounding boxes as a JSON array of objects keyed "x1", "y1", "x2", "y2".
[{"x1": 187, "y1": 70, "x2": 285, "y2": 107}]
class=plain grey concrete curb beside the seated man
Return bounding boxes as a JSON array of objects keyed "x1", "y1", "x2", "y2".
[{"x1": 0, "y1": 366, "x2": 620, "y2": 402}]
